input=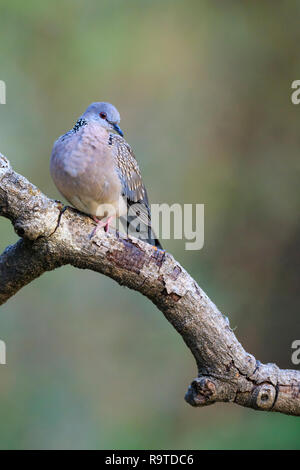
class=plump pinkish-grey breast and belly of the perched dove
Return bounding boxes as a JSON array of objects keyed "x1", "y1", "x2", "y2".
[{"x1": 50, "y1": 126, "x2": 121, "y2": 215}]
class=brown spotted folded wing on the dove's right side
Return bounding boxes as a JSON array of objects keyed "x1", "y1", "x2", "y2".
[{"x1": 109, "y1": 134, "x2": 150, "y2": 225}]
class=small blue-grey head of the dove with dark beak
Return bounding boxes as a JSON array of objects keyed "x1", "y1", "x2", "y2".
[{"x1": 81, "y1": 102, "x2": 124, "y2": 137}]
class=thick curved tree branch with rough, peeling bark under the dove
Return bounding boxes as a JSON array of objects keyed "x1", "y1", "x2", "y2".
[{"x1": 0, "y1": 154, "x2": 300, "y2": 416}]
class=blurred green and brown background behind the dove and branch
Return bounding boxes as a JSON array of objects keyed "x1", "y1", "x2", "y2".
[{"x1": 0, "y1": 0, "x2": 300, "y2": 449}]
